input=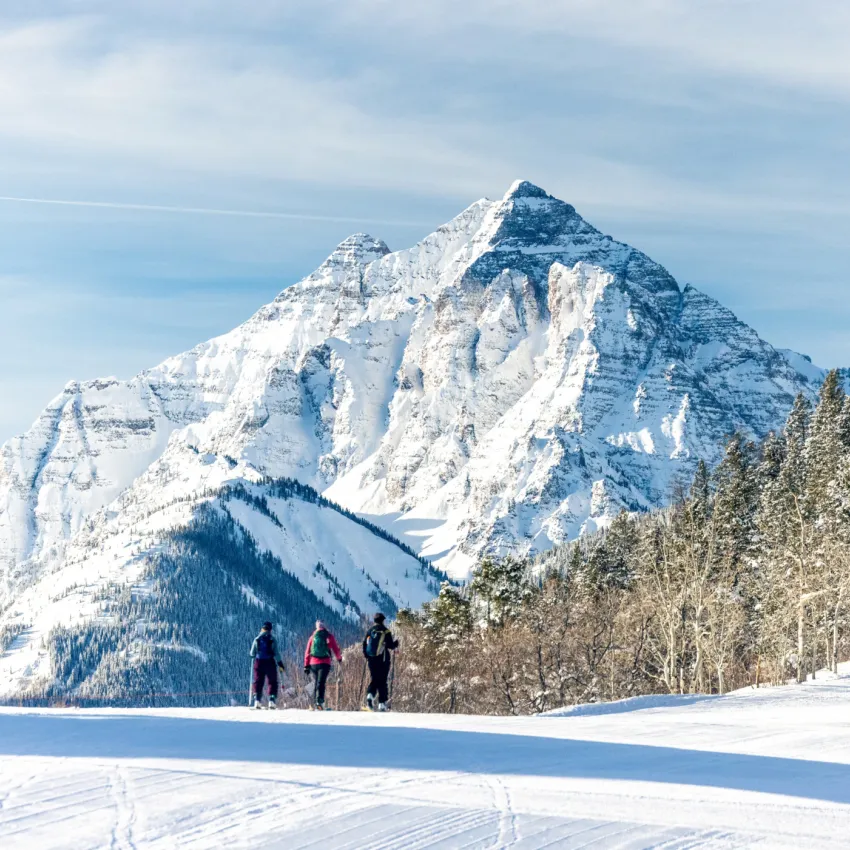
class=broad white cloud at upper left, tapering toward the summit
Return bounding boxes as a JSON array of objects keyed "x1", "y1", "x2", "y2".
[{"x1": 0, "y1": 19, "x2": 500, "y2": 195}]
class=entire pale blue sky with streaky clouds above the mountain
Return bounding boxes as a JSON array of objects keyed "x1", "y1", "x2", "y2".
[{"x1": 0, "y1": 0, "x2": 850, "y2": 441}]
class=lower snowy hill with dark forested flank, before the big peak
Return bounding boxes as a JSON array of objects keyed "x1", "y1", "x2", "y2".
[{"x1": 0, "y1": 464, "x2": 440, "y2": 702}]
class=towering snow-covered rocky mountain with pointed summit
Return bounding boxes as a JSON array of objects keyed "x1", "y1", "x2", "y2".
[{"x1": 0, "y1": 182, "x2": 820, "y2": 588}]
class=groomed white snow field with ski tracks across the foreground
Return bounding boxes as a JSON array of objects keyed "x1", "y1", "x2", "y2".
[{"x1": 0, "y1": 678, "x2": 850, "y2": 850}]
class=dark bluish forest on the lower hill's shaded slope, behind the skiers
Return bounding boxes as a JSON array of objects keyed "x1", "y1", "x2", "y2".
[{"x1": 0, "y1": 504, "x2": 361, "y2": 706}]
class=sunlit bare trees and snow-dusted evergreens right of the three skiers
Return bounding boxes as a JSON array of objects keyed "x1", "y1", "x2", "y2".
[{"x1": 394, "y1": 371, "x2": 850, "y2": 714}]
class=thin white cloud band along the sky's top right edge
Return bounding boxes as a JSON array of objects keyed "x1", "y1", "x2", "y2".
[{"x1": 340, "y1": 0, "x2": 850, "y2": 97}]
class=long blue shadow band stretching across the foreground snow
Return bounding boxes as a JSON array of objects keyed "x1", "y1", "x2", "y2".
[{"x1": 0, "y1": 713, "x2": 850, "y2": 803}]
